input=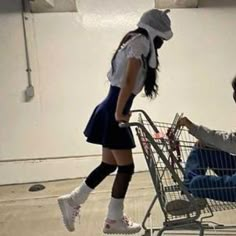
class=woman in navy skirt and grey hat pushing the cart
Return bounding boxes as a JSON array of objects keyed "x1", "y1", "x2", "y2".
[{"x1": 58, "y1": 9, "x2": 173, "y2": 234}]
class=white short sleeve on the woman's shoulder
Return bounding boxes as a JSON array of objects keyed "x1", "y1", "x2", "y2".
[{"x1": 125, "y1": 35, "x2": 150, "y2": 59}]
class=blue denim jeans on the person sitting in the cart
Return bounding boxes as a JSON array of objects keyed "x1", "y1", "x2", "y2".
[{"x1": 184, "y1": 148, "x2": 236, "y2": 202}]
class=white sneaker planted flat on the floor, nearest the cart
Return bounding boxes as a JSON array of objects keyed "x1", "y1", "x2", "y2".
[{"x1": 103, "y1": 216, "x2": 141, "y2": 234}]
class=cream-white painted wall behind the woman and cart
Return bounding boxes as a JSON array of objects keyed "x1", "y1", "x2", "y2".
[{"x1": 0, "y1": 0, "x2": 236, "y2": 184}]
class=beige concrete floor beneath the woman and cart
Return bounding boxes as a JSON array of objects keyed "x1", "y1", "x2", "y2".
[{"x1": 0, "y1": 172, "x2": 236, "y2": 236}]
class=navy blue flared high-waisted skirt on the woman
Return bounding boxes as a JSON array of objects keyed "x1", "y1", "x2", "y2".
[{"x1": 84, "y1": 86, "x2": 135, "y2": 149}]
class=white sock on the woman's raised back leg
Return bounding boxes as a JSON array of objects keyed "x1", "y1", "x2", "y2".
[{"x1": 70, "y1": 182, "x2": 93, "y2": 206}]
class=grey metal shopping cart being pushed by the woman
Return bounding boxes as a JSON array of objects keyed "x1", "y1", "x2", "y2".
[{"x1": 120, "y1": 110, "x2": 236, "y2": 236}]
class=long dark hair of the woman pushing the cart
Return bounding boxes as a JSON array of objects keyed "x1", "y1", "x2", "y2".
[{"x1": 111, "y1": 28, "x2": 159, "y2": 99}]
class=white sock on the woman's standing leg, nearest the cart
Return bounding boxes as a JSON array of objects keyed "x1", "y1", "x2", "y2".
[{"x1": 107, "y1": 197, "x2": 124, "y2": 220}]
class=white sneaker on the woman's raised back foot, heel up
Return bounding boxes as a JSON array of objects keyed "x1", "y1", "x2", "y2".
[{"x1": 57, "y1": 194, "x2": 80, "y2": 232}]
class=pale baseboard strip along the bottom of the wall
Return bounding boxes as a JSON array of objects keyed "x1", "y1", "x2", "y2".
[{"x1": 0, "y1": 153, "x2": 147, "y2": 185}]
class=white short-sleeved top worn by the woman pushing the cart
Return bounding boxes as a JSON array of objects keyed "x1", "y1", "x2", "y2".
[{"x1": 107, "y1": 34, "x2": 150, "y2": 95}]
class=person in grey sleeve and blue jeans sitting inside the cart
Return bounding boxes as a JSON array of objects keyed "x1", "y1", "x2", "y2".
[{"x1": 177, "y1": 77, "x2": 236, "y2": 202}]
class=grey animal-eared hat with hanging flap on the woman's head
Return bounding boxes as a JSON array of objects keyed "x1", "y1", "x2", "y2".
[{"x1": 137, "y1": 9, "x2": 173, "y2": 68}]
